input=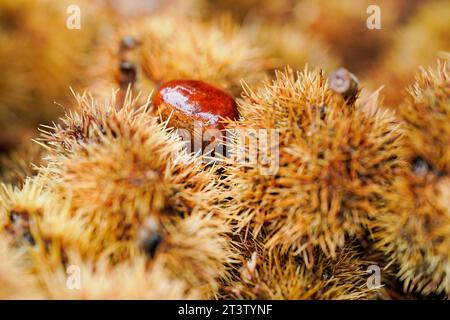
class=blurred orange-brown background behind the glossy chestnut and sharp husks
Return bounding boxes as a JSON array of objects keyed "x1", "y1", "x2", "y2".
[{"x1": 0, "y1": 0, "x2": 450, "y2": 181}]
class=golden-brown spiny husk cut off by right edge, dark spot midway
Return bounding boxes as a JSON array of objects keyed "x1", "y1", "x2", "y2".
[{"x1": 375, "y1": 59, "x2": 450, "y2": 296}]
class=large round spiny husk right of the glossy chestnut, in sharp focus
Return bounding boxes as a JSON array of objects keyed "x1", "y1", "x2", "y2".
[{"x1": 224, "y1": 69, "x2": 403, "y2": 265}]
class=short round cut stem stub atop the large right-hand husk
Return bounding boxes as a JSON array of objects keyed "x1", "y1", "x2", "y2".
[{"x1": 329, "y1": 68, "x2": 359, "y2": 105}]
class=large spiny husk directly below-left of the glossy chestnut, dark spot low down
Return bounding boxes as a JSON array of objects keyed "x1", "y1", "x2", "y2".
[{"x1": 35, "y1": 95, "x2": 231, "y2": 295}]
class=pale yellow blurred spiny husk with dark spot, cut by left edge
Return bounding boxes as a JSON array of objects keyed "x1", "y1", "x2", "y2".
[{"x1": 0, "y1": 176, "x2": 92, "y2": 274}]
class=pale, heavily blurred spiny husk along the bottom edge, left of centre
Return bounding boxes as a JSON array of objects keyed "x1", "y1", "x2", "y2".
[{"x1": 38, "y1": 257, "x2": 201, "y2": 300}]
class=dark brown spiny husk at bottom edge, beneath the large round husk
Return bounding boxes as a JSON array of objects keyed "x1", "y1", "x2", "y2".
[{"x1": 223, "y1": 240, "x2": 382, "y2": 300}]
